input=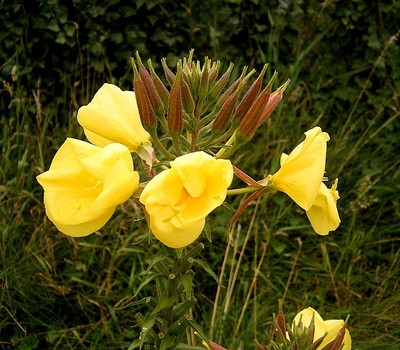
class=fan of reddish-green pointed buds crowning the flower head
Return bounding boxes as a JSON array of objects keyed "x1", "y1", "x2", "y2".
[{"x1": 131, "y1": 50, "x2": 289, "y2": 158}]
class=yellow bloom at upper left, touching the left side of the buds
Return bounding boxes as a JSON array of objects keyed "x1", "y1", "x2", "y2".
[{"x1": 78, "y1": 84, "x2": 150, "y2": 152}]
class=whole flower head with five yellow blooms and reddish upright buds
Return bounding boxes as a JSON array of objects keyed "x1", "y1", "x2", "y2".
[{"x1": 37, "y1": 52, "x2": 340, "y2": 248}]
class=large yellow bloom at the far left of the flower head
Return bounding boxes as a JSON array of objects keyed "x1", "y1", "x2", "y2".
[{"x1": 37, "y1": 138, "x2": 139, "y2": 237}]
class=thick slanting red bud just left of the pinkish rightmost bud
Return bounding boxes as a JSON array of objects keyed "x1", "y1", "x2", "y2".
[{"x1": 236, "y1": 88, "x2": 270, "y2": 142}]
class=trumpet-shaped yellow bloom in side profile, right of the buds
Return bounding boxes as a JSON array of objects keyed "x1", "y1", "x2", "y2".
[{"x1": 269, "y1": 127, "x2": 329, "y2": 210}]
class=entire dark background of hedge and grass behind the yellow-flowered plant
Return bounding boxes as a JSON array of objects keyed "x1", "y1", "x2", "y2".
[{"x1": 0, "y1": 0, "x2": 400, "y2": 349}]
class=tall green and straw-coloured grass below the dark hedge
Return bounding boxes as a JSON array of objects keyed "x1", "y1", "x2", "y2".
[{"x1": 0, "y1": 41, "x2": 400, "y2": 350}]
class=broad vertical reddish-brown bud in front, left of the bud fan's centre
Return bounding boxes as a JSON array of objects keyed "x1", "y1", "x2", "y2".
[{"x1": 168, "y1": 65, "x2": 183, "y2": 135}]
